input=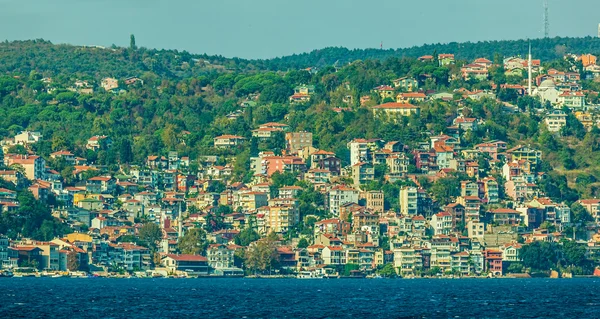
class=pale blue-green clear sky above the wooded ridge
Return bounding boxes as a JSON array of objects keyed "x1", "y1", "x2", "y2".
[{"x1": 0, "y1": 0, "x2": 600, "y2": 58}]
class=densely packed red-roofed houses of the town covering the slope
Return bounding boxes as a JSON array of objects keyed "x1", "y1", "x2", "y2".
[{"x1": 0, "y1": 50, "x2": 600, "y2": 278}]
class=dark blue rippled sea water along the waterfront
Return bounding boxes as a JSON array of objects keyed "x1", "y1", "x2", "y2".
[{"x1": 0, "y1": 278, "x2": 600, "y2": 319}]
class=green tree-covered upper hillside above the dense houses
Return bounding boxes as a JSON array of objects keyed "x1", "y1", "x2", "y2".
[{"x1": 0, "y1": 38, "x2": 600, "y2": 204}]
